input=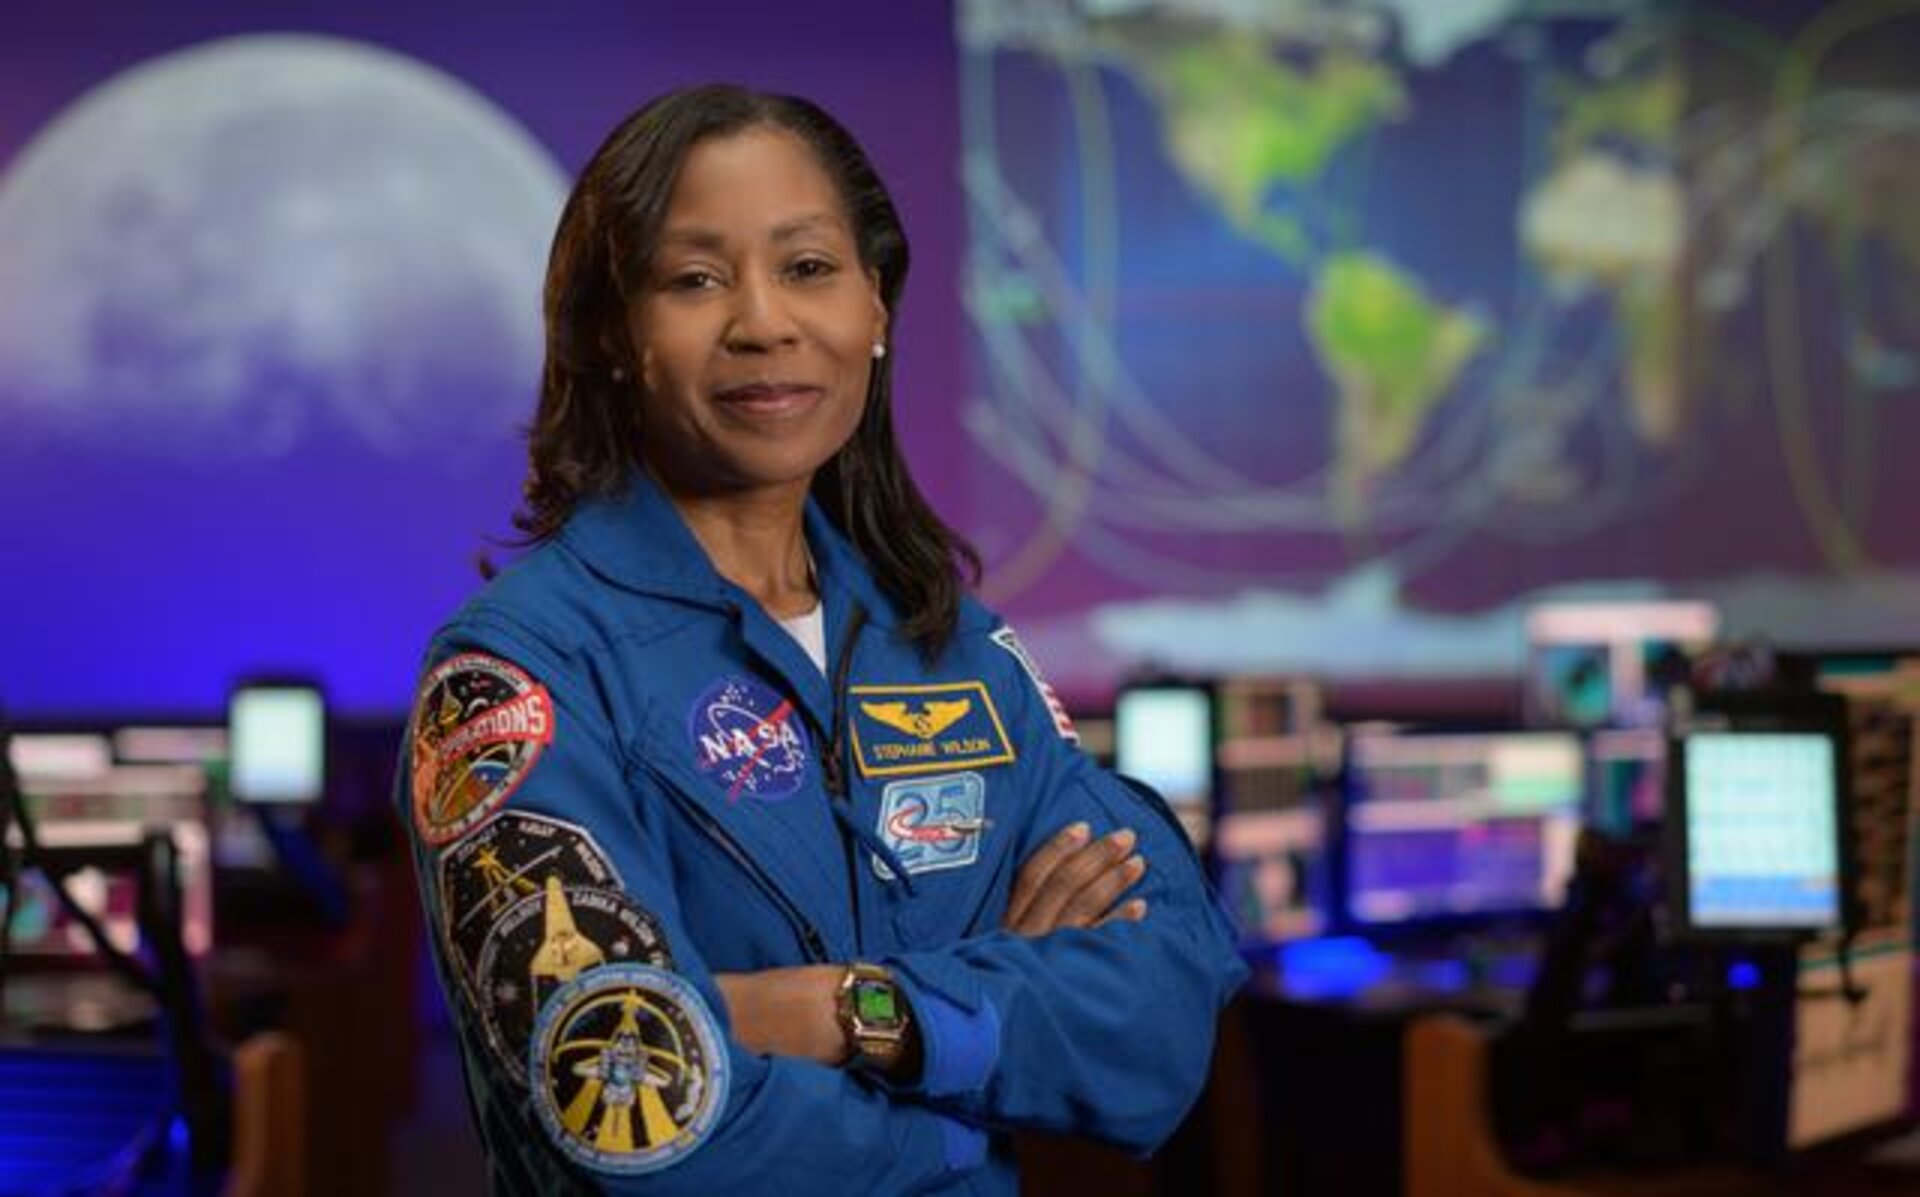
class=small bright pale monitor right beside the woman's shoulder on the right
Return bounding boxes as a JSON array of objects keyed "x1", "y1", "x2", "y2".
[{"x1": 1114, "y1": 684, "x2": 1213, "y2": 851}]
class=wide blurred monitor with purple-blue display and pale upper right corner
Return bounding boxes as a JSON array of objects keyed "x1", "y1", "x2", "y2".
[{"x1": 1344, "y1": 726, "x2": 1584, "y2": 928}]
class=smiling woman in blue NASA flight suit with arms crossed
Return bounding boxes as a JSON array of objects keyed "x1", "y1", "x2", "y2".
[{"x1": 401, "y1": 86, "x2": 1240, "y2": 1193}]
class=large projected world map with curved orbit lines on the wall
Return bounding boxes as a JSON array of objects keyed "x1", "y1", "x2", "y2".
[{"x1": 960, "y1": 0, "x2": 1920, "y2": 687}]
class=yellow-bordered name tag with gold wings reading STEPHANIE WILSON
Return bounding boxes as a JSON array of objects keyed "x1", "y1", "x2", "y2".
[{"x1": 847, "y1": 682, "x2": 1014, "y2": 778}]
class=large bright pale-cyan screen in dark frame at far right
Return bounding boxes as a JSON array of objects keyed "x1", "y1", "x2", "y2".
[{"x1": 1686, "y1": 732, "x2": 1841, "y2": 930}]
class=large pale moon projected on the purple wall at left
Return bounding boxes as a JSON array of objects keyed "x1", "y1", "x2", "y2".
[{"x1": 0, "y1": 35, "x2": 566, "y2": 463}]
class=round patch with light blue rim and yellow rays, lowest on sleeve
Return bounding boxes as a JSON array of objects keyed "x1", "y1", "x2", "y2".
[{"x1": 528, "y1": 965, "x2": 728, "y2": 1174}]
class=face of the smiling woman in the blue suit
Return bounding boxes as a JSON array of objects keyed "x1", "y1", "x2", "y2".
[{"x1": 626, "y1": 129, "x2": 887, "y2": 496}]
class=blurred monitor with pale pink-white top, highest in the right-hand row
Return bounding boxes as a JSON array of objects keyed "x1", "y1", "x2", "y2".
[{"x1": 1524, "y1": 599, "x2": 1720, "y2": 728}]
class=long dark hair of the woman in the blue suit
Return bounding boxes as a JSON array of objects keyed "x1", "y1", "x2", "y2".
[{"x1": 513, "y1": 85, "x2": 979, "y2": 661}]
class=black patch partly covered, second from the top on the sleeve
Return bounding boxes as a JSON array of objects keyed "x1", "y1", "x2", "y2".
[{"x1": 438, "y1": 811, "x2": 620, "y2": 1005}]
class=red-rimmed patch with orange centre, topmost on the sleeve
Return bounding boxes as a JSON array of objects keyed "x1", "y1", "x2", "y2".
[{"x1": 411, "y1": 653, "x2": 553, "y2": 843}]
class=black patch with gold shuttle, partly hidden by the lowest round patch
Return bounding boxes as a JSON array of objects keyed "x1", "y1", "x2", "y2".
[{"x1": 474, "y1": 878, "x2": 674, "y2": 1084}]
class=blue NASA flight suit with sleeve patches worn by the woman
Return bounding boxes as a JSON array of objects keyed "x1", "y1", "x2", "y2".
[{"x1": 399, "y1": 476, "x2": 1244, "y2": 1197}]
